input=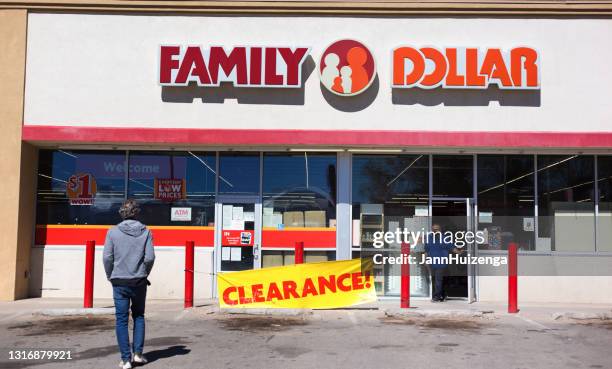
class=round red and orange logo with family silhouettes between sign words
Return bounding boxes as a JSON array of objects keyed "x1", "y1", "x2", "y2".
[{"x1": 319, "y1": 40, "x2": 376, "y2": 96}]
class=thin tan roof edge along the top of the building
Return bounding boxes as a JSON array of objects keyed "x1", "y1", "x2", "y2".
[{"x1": 0, "y1": 0, "x2": 612, "y2": 17}]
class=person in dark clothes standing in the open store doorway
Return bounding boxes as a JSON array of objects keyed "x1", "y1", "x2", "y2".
[{"x1": 425, "y1": 223, "x2": 463, "y2": 302}]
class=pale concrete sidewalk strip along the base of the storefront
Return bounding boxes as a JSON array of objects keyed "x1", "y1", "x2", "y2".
[{"x1": 0, "y1": 298, "x2": 612, "y2": 321}]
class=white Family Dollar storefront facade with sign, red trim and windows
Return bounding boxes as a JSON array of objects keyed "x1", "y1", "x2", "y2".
[{"x1": 2, "y1": 0, "x2": 612, "y2": 302}]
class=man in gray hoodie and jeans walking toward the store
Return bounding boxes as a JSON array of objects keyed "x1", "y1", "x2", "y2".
[{"x1": 102, "y1": 199, "x2": 155, "y2": 369}]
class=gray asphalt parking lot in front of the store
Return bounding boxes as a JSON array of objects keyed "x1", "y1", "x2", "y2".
[{"x1": 0, "y1": 305, "x2": 612, "y2": 369}]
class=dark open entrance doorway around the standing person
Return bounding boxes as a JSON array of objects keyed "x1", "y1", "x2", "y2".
[{"x1": 431, "y1": 198, "x2": 476, "y2": 302}]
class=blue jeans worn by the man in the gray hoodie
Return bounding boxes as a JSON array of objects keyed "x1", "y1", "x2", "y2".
[{"x1": 113, "y1": 284, "x2": 147, "y2": 362}]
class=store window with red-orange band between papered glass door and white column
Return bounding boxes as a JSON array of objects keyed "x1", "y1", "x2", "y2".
[{"x1": 262, "y1": 152, "x2": 336, "y2": 267}]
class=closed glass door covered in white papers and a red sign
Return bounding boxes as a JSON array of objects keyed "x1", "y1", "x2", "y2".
[{"x1": 215, "y1": 196, "x2": 261, "y2": 272}]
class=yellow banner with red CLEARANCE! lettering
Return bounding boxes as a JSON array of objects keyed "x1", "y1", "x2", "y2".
[{"x1": 217, "y1": 259, "x2": 376, "y2": 309}]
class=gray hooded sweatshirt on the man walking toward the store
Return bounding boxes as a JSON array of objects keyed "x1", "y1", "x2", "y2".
[{"x1": 102, "y1": 219, "x2": 155, "y2": 284}]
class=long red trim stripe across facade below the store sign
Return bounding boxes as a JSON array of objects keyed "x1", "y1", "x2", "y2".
[{"x1": 22, "y1": 125, "x2": 612, "y2": 148}]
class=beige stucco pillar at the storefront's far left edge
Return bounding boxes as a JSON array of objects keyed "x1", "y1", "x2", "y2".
[{"x1": 0, "y1": 10, "x2": 36, "y2": 300}]
